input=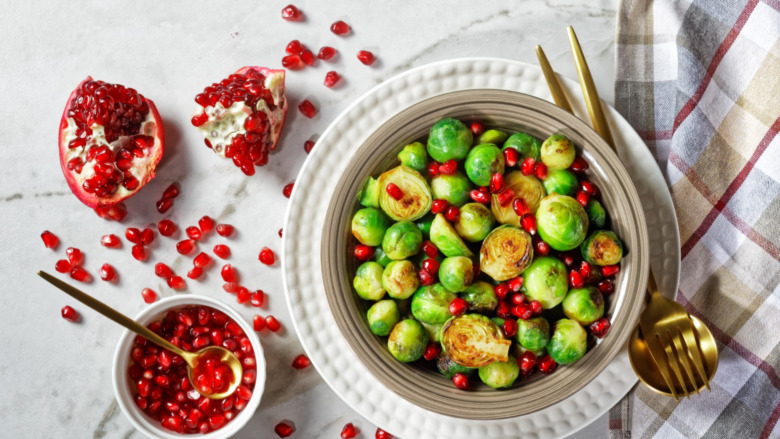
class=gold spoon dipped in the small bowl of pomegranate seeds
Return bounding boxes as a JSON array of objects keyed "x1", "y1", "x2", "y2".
[{"x1": 38, "y1": 271, "x2": 243, "y2": 399}]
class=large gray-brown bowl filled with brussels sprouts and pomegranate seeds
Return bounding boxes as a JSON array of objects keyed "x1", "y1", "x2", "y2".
[{"x1": 321, "y1": 89, "x2": 649, "y2": 420}]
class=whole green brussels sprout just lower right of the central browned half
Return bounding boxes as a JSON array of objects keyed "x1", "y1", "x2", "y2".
[{"x1": 523, "y1": 256, "x2": 569, "y2": 309}]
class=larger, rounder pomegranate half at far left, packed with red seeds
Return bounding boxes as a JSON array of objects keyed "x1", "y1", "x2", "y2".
[{"x1": 59, "y1": 76, "x2": 165, "y2": 208}]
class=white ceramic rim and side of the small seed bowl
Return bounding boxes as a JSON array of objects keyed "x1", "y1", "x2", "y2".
[{"x1": 113, "y1": 294, "x2": 266, "y2": 439}]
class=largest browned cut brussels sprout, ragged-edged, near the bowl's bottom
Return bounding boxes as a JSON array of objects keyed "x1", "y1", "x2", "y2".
[{"x1": 441, "y1": 314, "x2": 512, "y2": 367}]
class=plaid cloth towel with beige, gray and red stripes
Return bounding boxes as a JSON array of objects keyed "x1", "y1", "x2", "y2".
[{"x1": 610, "y1": 0, "x2": 780, "y2": 439}]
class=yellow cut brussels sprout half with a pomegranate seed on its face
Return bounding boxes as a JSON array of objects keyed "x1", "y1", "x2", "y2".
[{"x1": 377, "y1": 165, "x2": 433, "y2": 221}]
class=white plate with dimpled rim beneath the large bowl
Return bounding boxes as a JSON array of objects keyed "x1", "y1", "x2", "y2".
[{"x1": 282, "y1": 58, "x2": 680, "y2": 439}]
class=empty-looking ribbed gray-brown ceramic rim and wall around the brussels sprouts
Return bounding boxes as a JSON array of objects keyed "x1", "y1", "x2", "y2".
[{"x1": 321, "y1": 89, "x2": 649, "y2": 419}]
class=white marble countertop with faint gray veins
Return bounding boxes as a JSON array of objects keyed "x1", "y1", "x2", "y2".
[{"x1": 0, "y1": 0, "x2": 618, "y2": 439}]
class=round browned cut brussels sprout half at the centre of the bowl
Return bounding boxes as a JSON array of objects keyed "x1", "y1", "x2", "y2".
[{"x1": 479, "y1": 225, "x2": 534, "y2": 282}]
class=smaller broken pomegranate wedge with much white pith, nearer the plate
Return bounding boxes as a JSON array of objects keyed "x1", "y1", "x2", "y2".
[{"x1": 192, "y1": 67, "x2": 287, "y2": 175}]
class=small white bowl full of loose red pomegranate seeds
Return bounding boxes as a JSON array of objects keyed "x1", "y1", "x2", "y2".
[{"x1": 113, "y1": 294, "x2": 265, "y2": 438}]
